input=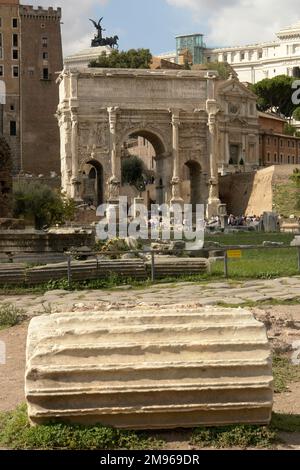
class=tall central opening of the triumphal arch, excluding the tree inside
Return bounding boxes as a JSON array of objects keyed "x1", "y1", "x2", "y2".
[{"x1": 122, "y1": 128, "x2": 172, "y2": 208}]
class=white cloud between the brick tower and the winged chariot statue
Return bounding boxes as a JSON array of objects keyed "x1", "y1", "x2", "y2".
[{"x1": 24, "y1": 0, "x2": 110, "y2": 55}]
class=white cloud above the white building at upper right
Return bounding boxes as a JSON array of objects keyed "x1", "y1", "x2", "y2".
[{"x1": 166, "y1": 0, "x2": 300, "y2": 46}]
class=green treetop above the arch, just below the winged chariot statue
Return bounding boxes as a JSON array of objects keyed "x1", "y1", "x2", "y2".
[{"x1": 90, "y1": 49, "x2": 152, "y2": 69}]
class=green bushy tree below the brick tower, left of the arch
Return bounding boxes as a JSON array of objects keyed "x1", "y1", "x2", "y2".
[{"x1": 14, "y1": 183, "x2": 75, "y2": 229}]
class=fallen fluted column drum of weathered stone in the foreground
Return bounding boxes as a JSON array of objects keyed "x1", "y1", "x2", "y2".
[{"x1": 26, "y1": 307, "x2": 273, "y2": 429}]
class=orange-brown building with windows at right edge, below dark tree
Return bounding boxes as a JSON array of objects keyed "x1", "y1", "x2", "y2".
[{"x1": 259, "y1": 113, "x2": 300, "y2": 166}]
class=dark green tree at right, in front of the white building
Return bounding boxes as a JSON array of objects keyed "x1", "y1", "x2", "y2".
[{"x1": 251, "y1": 75, "x2": 296, "y2": 117}]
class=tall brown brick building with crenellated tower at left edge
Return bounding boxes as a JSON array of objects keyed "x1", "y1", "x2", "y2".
[{"x1": 0, "y1": 0, "x2": 63, "y2": 175}]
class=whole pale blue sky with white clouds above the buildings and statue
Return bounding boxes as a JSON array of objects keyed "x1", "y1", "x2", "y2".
[{"x1": 28, "y1": 0, "x2": 300, "y2": 55}]
